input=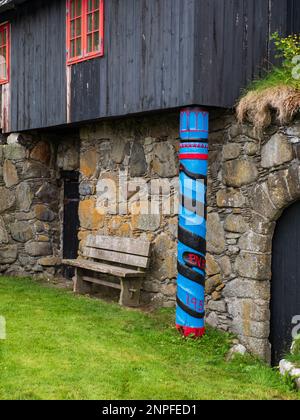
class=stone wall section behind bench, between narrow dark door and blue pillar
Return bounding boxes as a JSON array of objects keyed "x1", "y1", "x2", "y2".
[{"x1": 79, "y1": 114, "x2": 179, "y2": 306}]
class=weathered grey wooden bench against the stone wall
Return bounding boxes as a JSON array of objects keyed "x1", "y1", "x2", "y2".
[{"x1": 63, "y1": 235, "x2": 150, "y2": 307}]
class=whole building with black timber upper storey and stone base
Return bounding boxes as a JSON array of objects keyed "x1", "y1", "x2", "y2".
[{"x1": 0, "y1": 0, "x2": 300, "y2": 360}]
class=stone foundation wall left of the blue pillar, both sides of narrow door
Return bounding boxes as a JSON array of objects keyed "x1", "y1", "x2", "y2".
[{"x1": 0, "y1": 114, "x2": 179, "y2": 306}]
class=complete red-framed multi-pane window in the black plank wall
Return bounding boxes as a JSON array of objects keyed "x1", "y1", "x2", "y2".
[{"x1": 67, "y1": 0, "x2": 104, "y2": 65}]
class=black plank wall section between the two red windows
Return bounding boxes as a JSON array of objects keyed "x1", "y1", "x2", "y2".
[{"x1": 11, "y1": 0, "x2": 66, "y2": 131}]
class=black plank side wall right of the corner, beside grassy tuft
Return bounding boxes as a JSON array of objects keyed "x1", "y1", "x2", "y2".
[{"x1": 194, "y1": 0, "x2": 300, "y2": 107}]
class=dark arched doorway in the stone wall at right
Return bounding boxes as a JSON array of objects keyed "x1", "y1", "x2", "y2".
[{"x1": 270, "y1": 202, "x2": 300, "y2": 365}]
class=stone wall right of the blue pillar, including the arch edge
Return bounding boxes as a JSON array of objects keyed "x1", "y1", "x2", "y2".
[{"x1": 206, "y1": 114, "x2": 300, "y2": 360}]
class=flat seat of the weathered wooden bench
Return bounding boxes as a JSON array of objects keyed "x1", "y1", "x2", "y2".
[{"x1": 63, "y1": 258, "x2": 146, "y2": 278}]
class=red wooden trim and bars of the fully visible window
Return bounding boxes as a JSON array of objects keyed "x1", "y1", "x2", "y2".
[{"x1": 66, "y1": 0, "x2": 104, "y2": 66}]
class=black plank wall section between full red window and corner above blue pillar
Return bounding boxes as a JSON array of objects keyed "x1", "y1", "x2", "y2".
[{"x1": 71, "y1": 0, "x2": 195, "y2": 121}]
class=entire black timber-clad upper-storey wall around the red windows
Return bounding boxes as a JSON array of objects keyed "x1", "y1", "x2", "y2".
[{"x1": 0, "y1": 0, "x2": 300, "y2": 131}]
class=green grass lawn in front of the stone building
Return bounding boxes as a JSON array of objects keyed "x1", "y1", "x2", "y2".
[{"x1": 0, "y1": 277, "x2": 299, "y2": 399}]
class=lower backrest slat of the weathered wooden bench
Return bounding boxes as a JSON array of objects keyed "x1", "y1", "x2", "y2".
[{"x1": 83, "y1": 247, "x2": 149, "y2": 268}]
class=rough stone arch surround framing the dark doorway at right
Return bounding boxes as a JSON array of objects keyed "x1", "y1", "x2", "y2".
[{"x1": 235, "y1": 163, "x2": 300, "y2": 361}]
